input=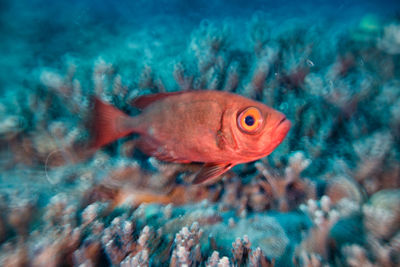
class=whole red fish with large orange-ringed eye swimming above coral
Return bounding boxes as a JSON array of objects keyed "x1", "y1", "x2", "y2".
[{"x1": 94, "y1": 90, "x2": 291, "y2": 184}]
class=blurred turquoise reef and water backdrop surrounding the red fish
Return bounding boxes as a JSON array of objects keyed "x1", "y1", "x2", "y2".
[{"x1": 0, "y1": 0, "x2": 400, "y2": 266}]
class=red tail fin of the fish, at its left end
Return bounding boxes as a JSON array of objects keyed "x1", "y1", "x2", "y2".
[{"x1": 91, "y1": 98, "x2": 134, "y2": 149}]
